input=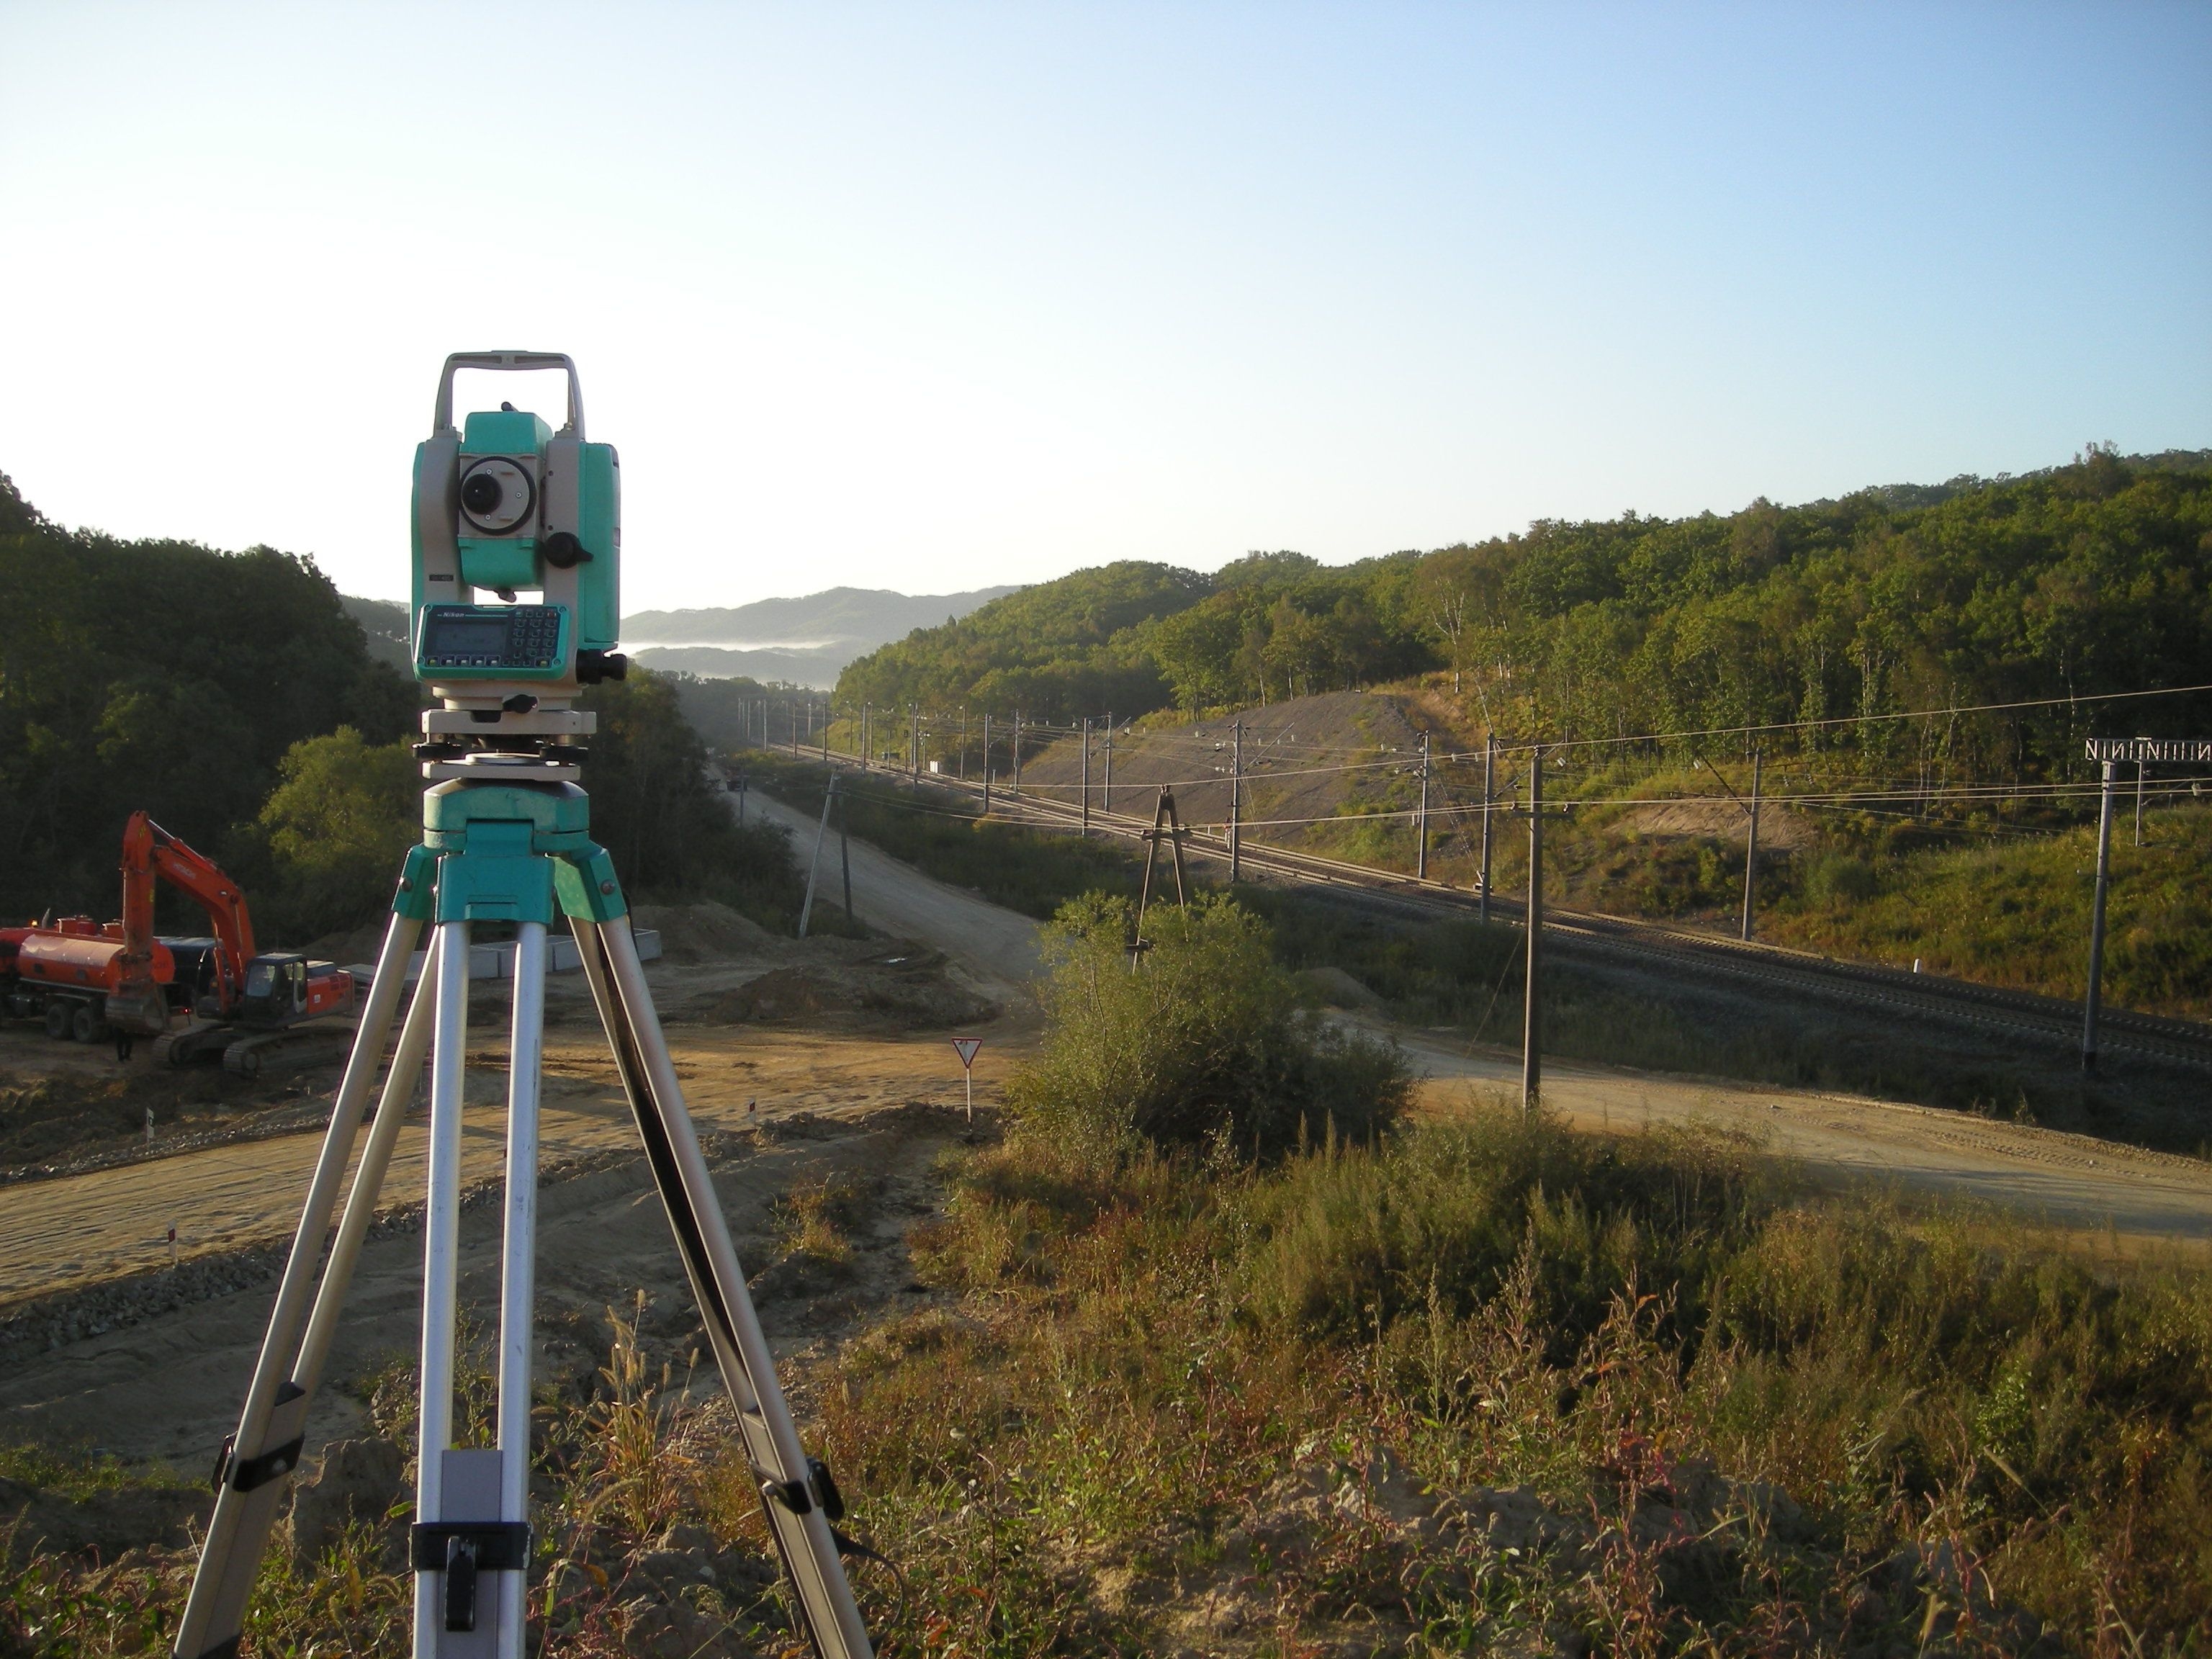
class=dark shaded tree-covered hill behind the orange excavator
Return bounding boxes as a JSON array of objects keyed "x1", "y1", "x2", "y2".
[{"x1": 0, "y1": 475, "x2": 416, "y2": 920}]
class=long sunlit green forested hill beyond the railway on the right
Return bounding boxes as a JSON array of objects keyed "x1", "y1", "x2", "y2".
[{"x1": 838, "y1": 447, "x2": 2212, "y2": 765}]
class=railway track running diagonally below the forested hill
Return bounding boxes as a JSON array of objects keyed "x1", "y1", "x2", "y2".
[{"x1": 827, "y1": 761, "x2": 2212, "y2": 1071}]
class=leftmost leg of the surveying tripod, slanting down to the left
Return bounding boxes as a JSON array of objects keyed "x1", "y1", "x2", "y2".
[{"x1": 173, "y1": 914, "x2": 423, "y2": 1659}]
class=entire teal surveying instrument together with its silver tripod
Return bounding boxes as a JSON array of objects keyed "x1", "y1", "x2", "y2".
[{"x1": 175, "y1": 351, "x2": 869, "y2": 1659}]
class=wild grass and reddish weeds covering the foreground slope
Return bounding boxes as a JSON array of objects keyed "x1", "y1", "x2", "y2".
[{"x1": 0, "y1": 1100, "x2": 2212, "y2": 1659}]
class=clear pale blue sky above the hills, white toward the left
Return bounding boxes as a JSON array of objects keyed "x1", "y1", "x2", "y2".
[{"x1": 0, "y1": 0, "x2": 2212, "y2": 608}]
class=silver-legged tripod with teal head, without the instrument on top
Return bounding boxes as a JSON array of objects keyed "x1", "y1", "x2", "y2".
[{"x1": 175, "y1": 765, "x2": 871, "y2": 1659}]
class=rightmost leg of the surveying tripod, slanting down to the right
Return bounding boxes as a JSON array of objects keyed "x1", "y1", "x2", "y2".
[{"x1": 573, "y1": 916, "x2": 871, "y2": 1659}]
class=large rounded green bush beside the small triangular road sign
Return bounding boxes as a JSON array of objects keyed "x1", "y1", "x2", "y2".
[{"x1": 1009, "y1": 894, "x2": 1411, "y2": 1161}]
